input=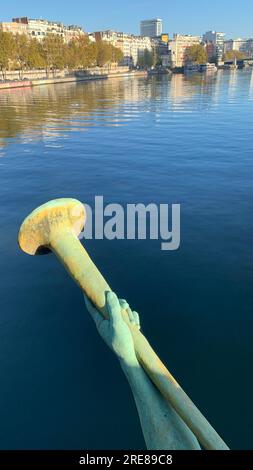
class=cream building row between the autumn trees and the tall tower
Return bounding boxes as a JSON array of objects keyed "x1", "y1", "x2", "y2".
[{"x1": 93, "y1": 30, "x2": 154, "y2": 67}]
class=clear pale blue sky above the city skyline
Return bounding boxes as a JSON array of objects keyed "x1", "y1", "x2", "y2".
[{"x1": 0, "y1": 0, "x2": 253, "y2": 38}]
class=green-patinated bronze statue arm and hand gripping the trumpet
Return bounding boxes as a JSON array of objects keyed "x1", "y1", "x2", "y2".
[{"x1": 84, "y1": 292, "x2": 200, "y2": 450}]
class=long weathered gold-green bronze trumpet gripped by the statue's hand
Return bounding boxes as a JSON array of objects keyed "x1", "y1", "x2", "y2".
[{"x1": 18, "y1": 199, "x2": 228, "y2": 450}]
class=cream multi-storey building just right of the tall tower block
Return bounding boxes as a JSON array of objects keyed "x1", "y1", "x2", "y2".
[{"x1": 169, "y1": 34, "x2": 201, "y2": 68}]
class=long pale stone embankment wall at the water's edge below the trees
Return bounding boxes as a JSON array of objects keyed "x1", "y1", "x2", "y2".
[{"x1": 0, "y1": 70, "x2": 147, "y2": 90}]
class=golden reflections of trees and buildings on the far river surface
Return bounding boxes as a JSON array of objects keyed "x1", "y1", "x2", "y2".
[{"x1": 0, "y1": 71, "x2": 252, "y2": 155}]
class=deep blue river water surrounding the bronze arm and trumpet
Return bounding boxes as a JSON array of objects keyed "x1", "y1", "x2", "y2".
[{"x1": 0, "y1": 71, "x2": 253, "y2": 449}]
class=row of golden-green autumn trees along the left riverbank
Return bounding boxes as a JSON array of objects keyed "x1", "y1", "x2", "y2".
[{"x1": 0, "y1": 31, "x2": 123, "y2": 72}]
